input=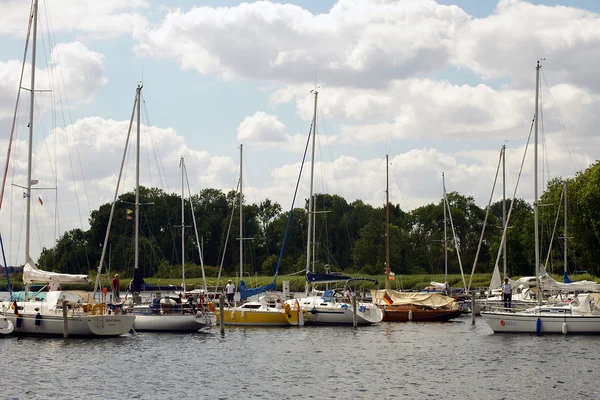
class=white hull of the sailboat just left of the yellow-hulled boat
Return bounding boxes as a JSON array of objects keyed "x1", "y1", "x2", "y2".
[{"x1": 132, "y1": 313, "x2": 216, "y2": 332}]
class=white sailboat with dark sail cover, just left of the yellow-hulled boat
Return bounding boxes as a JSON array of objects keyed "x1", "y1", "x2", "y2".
[{"x1": 98, "y1": 85, "x2": 215, "y2": 332}]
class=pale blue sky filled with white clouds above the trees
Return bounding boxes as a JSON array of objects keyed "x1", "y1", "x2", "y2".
[{"x1": 0, "y1": 0, "x2": 600, "y2": 264}]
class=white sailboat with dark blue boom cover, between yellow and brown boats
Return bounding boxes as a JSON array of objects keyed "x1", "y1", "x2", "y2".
[{"x1": 286, "y1": 90, "x2": 383, "y2": 326}]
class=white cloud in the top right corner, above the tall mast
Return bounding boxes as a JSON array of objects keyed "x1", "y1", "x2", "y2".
[{"x1": 453, "y1": 0, "x2": 600, "y2": 91}]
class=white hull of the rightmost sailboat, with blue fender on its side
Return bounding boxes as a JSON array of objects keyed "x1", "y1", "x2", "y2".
[{"x1": 481, "y1": 311, "x2": 600, "y2": 334}]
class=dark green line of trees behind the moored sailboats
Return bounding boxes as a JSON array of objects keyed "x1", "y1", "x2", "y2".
[{"x1": 39, "y1": 161, "x2": 600, "y2": 278}]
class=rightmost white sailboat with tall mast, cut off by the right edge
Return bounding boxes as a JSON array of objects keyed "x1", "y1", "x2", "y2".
[{"x1": 481, "y1": 61, "x2": 600, "y2": 334}]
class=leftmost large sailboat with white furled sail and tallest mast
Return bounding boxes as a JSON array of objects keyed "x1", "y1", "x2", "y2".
[{"x1": 0, "y1": 0, "x2": 135, "y2": 337}]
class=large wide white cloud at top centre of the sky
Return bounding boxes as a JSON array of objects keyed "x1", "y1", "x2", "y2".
[{"x1": 135, "y1": 0, "x2": 469, "y2": 87}]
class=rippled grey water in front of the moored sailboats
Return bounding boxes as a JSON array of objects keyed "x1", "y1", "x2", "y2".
[{"x1": 0, "y1": 317, "x2": 600, "y2": 399}]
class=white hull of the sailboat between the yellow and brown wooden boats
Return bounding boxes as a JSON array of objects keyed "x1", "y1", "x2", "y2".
[{"x1": 288, "y1": 296, "x2": 383, "y2": 325}]
